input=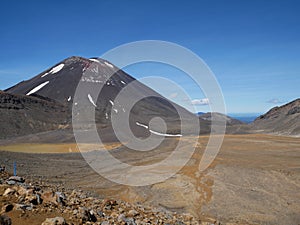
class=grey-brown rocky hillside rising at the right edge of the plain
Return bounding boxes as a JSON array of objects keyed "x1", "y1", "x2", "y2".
[{"x1": 250, "y1": 99, "x2": 300, "y2": 136}]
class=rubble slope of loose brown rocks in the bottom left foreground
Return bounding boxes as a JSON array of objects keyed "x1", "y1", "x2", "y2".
[{"x1": 0, "y1": 172, "x2": 219, "y2": 225}]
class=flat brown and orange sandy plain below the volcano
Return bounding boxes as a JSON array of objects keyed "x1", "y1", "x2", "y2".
[{"x1": 0, "y1": 134, "x2": 300, "y2": 224}]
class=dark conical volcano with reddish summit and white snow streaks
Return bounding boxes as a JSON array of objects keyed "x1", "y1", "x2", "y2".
[{"x1": 5, "y1": 56, "x2": 205, "y2": 141}]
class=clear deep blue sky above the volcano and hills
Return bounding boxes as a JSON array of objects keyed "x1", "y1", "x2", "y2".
[{"x1": 0, "y1": 0, "x2": 300, "y2": 113}]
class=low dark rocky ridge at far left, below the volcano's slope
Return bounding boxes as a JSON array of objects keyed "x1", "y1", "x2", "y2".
[{"x1": 0, "y1": 91, "x2": 70, "y2": 138}]
